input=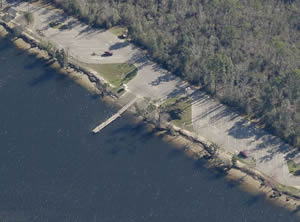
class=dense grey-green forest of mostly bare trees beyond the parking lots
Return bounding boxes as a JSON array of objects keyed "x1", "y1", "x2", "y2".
[{"x1": 43, "y1": 0, "x2": 300, "y2": 146}]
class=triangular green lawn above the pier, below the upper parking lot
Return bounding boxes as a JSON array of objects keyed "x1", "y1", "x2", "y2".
[{"x1": 86, "y1": 63, "x2": 137, "y2": 89}]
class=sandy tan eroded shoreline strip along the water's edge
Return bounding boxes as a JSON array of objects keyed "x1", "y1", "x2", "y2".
[{"x1": 0, "y1": 23, "x2": 300, "y2": 216}]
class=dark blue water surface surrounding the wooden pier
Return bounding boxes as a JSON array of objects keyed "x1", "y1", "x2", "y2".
[{"x1": 0, "y1": 40, "x2": 298, "y2": 222}]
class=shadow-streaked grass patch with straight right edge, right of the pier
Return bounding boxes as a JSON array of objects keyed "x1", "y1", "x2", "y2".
[{"x1": 161, "y1": 97, "x2": 193, "y2": 130}]
